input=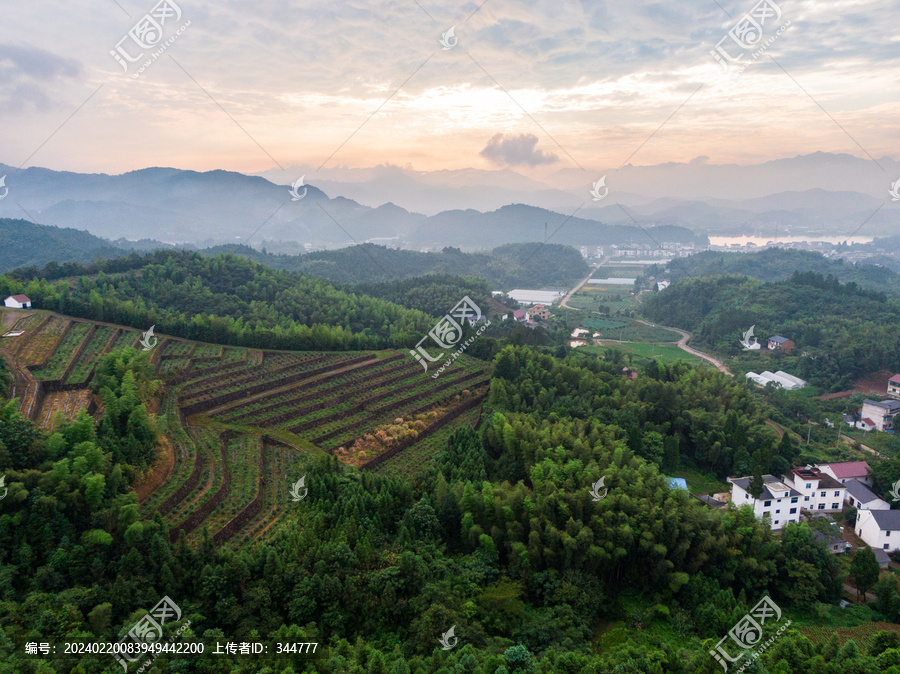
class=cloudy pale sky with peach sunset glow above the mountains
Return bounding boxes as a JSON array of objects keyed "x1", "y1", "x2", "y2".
[{"x1": 0, "y1": 0, "x2": 900, "y2": 182}]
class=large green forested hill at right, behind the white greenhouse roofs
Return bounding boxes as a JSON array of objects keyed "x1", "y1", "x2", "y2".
[{"x1": 644, "y1": 272, "x2": 900, "y2": 388}]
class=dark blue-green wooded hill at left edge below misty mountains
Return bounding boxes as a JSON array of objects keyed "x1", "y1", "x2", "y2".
[{"x1": 0, "y1": 218, "x2": 127, "y2": 272}]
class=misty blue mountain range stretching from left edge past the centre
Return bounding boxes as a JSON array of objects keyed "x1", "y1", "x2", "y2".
[{"x1": 0, "y1": 165, "x2": 706, "y2": 250}]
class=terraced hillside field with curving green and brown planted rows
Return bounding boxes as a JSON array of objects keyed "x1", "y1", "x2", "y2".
[{"x1": 0, "y1": 312, "x2": 489, "y2": 545}]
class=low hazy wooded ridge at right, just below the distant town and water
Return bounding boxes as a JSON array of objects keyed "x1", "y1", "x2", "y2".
[{"x1": 647, "y1": 248, "x2": 900, "y2": 293}]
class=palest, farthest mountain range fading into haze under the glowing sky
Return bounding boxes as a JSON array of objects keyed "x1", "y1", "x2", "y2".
[{"x1": 253, "y1": 152, "x2": 900, "y2": 238}]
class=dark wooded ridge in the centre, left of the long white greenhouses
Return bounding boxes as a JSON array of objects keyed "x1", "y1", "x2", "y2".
[{"x1": 204, "y1": 243, "x2": 590, "y2": 290}]
